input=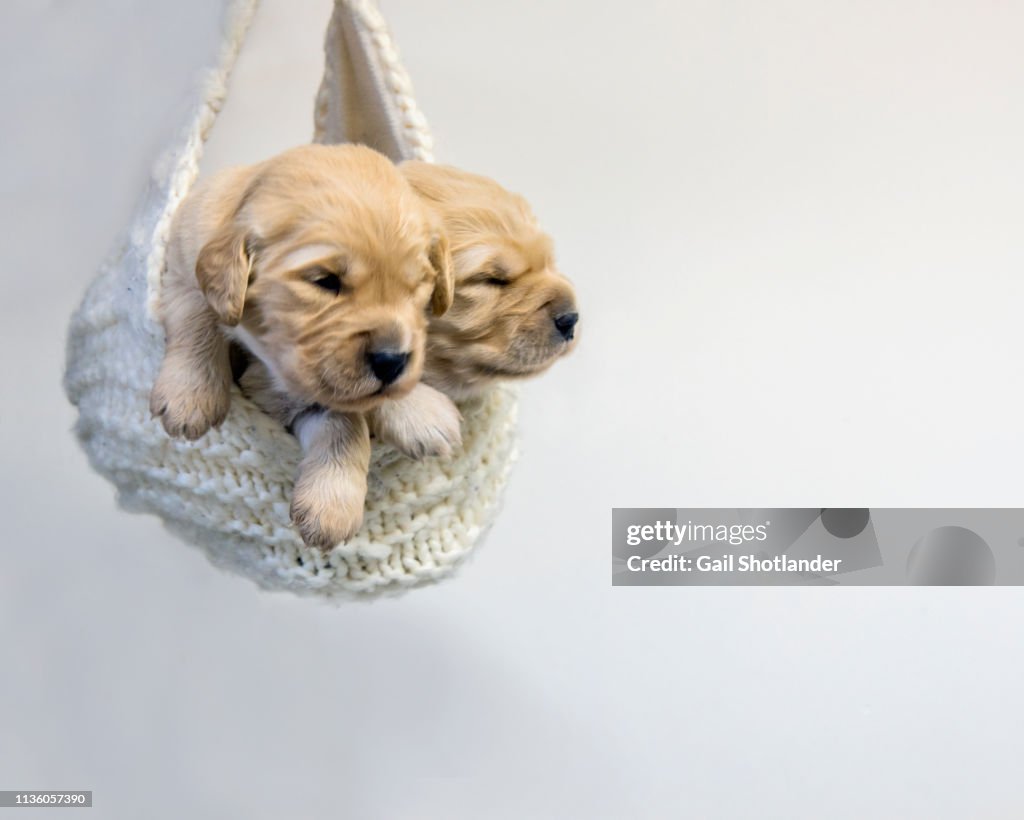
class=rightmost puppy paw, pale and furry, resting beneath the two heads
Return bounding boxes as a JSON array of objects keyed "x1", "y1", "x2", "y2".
[{"x1": 374, "y1": 383, "x2": 462, "y2": 459}]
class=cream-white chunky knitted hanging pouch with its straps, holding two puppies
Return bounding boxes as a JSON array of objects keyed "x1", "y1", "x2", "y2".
[{"x1": 65, "y1": 0, "x2": 515, "y2": 597}]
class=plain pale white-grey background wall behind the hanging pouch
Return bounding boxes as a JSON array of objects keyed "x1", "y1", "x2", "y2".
[{"x1": 0, "y1": 0, "x2": 1024, "y2": 818}]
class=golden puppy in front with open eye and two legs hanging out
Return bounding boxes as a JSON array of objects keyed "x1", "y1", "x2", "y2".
[{"x1": 150, "y1": 145, "x2": 453, "y2": 549}]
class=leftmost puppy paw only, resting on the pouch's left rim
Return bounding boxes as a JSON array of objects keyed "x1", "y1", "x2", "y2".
[{"x1": 150, "y1": 362, "x2": 231, "y2": 441}]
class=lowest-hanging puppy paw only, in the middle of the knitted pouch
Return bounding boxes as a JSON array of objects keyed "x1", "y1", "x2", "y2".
[{"x1": 292, "y1": 466, "x2": 367, "y2": 552}]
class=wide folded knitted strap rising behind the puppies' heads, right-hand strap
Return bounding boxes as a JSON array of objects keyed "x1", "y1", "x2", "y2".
[{"x1": 313, "y1": 0, "x2": 433, "y2": 162}]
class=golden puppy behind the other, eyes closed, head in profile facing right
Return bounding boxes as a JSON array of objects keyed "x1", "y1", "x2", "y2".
[{"x1": 241, "y1": 162, "x2": 579, "y2": 466}]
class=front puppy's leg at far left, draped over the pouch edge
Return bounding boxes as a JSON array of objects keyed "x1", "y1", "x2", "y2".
[{"x1": 150, "y1": 291, "x2": 231, "y2": 439}]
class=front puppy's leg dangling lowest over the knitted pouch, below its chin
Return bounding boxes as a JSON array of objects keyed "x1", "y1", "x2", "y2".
[{"x1": 292, "y1": 408, "x2": 370, "y2": 552}]
